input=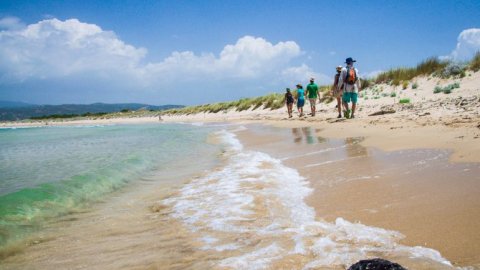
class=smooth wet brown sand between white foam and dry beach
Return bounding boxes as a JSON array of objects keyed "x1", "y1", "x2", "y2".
[{"x1": 238, "y1": 126, "x2": 480, "y2": 268}]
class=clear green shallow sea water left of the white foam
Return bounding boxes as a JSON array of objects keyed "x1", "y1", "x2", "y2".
[{"x1": 0, "y1": 125, "x2": 220, "y2": 250}]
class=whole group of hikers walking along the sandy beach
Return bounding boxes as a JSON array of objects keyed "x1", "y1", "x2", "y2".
[{"x1": 285, "y1": 57, "x2": 360, "y2": 118}]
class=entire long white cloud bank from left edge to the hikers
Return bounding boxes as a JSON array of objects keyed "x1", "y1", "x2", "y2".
[{"x1": 0, "y1": 17, "x2": 329, "y2": 103}]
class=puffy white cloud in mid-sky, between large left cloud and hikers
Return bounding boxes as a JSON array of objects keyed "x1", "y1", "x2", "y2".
[{"x1": 146, "y1": 36, "x2": 301, "y2": 82}]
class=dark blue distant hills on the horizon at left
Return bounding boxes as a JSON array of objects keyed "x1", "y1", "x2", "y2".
[{"x1": 0, "y1": 101, "x2": 184, "y2": 121}]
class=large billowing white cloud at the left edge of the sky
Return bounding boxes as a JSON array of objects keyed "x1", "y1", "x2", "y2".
[{"x1": 0, "y1": 19, "x2": 147, "y2": 81}]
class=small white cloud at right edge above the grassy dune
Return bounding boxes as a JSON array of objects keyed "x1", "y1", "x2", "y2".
[{"x1": 441, "y1": 28, "x2": 480, "y2": 61}]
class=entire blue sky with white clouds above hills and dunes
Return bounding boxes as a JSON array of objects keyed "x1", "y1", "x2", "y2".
[{"x1": 0, "y1": 0, "x2": 480, "y2": 105}]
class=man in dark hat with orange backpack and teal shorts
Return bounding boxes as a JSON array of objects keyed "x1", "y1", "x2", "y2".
[{"x1": 337, "y1": 57, "x2": 360, "y2": 118}]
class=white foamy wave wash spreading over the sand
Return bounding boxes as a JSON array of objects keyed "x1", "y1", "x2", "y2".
[{"x1": 163, "y1": 130, "x2": 451, "y2": 269}]
